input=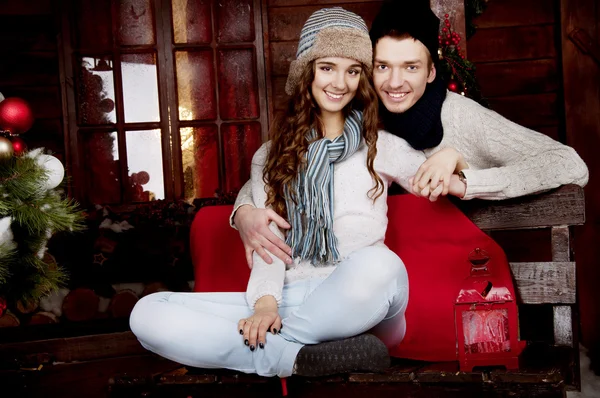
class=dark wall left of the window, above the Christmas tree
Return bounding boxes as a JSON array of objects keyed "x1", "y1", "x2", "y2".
[{"x1": 0, "y1": 0, "x2": 65, "y2": 160}]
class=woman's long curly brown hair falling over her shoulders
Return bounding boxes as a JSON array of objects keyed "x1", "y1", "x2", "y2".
[{"x1": 263, "y1": 61, "x2": 383, "y2": 218}]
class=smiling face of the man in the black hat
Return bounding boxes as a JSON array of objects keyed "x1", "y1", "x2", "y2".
[{"x1": 373, "y1": 36, "x2": 436, "y2": 113}]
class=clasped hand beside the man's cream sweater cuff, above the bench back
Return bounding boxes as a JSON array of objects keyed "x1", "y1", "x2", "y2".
[{"x1": 411, "y1": 148, "x2": 468, "y2": 199}]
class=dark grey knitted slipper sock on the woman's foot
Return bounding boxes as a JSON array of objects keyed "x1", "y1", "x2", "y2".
[{"x1": 294, "y1": 334, "x2": 390, "y2": 377}]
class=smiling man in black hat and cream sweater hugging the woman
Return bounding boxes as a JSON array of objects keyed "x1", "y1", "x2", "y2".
[{"x1": 231, "y1": 2, "x2": 588, "y2": 266}]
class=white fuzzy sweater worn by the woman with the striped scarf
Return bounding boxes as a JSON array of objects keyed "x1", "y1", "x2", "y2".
[{"x1": 246, "y1": 131, "x2": 426, "y2": 308}]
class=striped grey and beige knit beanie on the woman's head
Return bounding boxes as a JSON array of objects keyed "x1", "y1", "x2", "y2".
[{"x1": 285, "y1": 7, "x2": 372, "y2": 95}]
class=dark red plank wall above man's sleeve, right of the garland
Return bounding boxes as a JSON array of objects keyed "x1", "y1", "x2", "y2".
[{"x1": 467, "y1": 0, "x2": 565, "y2": 142}]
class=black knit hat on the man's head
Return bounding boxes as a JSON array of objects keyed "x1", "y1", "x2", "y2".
[{"x1": 369, "y1": 0, "x2": 440, "y2": 63}]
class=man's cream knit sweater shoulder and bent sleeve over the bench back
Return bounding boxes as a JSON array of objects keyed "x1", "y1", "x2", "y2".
[{"x1": 434, "y1": 92, "x2": 588, "y2": 200}]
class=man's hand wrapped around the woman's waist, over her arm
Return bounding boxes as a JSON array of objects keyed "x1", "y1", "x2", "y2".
[{"x1": 233, "y1": 206, "x2": 292, "y2": 268}]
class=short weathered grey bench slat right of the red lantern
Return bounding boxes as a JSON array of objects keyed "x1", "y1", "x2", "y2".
[{"x1": 510, "y1": 262, "x2": 577, "y2": 304}]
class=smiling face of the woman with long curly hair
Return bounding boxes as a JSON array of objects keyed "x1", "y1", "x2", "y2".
[{"x1": 310, "y1": 57, "x2": 362, "y2": 114}]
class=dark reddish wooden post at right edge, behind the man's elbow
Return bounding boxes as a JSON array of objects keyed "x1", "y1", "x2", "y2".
[{"x1": 560, "y1": 0, "x2": 600, "y2": 355}]
